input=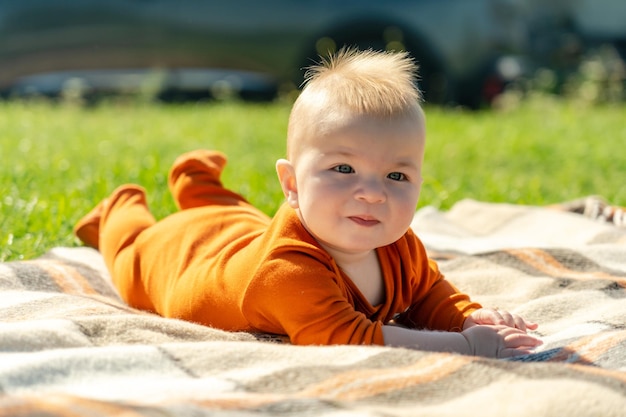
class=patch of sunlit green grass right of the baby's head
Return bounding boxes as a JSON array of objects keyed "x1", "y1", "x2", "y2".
[{"x1": 422, "y1": 100, "x2": 626, "y2": 208}]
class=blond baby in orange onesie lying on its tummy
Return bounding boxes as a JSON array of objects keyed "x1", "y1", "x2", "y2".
[{"x1": 75, "y1": 49, "x2": 541, "y2": 357}]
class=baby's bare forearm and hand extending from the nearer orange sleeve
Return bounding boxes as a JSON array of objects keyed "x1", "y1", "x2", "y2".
[{"x1": 383, "y1": 325, "x2": 541, "y2": 358}]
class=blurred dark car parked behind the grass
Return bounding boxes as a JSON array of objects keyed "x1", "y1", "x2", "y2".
[{"x1": 0, "y1": 0, "x2": 526, "y2": 106}]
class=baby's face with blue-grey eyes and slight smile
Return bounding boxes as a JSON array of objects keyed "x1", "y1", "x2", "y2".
[{"x1": 288, "y1": 114, "x2": 425, "y2": 256}]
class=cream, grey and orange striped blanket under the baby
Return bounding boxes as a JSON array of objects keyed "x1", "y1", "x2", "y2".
[{"x1": 0, "y1": 201, "x2": 626, "y2": 417}]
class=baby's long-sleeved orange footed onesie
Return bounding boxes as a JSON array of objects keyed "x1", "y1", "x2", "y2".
[{"x1": 76, "y1": 151, "x2": 480, "y2": 344}]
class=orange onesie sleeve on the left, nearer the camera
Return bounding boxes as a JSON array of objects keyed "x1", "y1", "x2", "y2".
[{"x1": 241, "y1": 251, "x2": 384, "y2": 345}]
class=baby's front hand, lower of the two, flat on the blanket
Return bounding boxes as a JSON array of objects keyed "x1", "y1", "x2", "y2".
[{"x1": 461, "y1": 325, "x2": 542, "y2": 358}]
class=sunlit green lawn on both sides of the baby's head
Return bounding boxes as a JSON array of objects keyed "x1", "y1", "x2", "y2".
[{"x1": 0, "y1": 100, "x2": 626, "y2": 261}]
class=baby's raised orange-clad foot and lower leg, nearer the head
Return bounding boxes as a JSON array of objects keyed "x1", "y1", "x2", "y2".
[{"x1": 169, "y1": 150, "x2": 248, "y2": 210}]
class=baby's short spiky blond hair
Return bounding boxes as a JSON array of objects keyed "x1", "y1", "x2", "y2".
[{"x1": 287, "y1": 48, "x2": 421, "y2": 157}]
